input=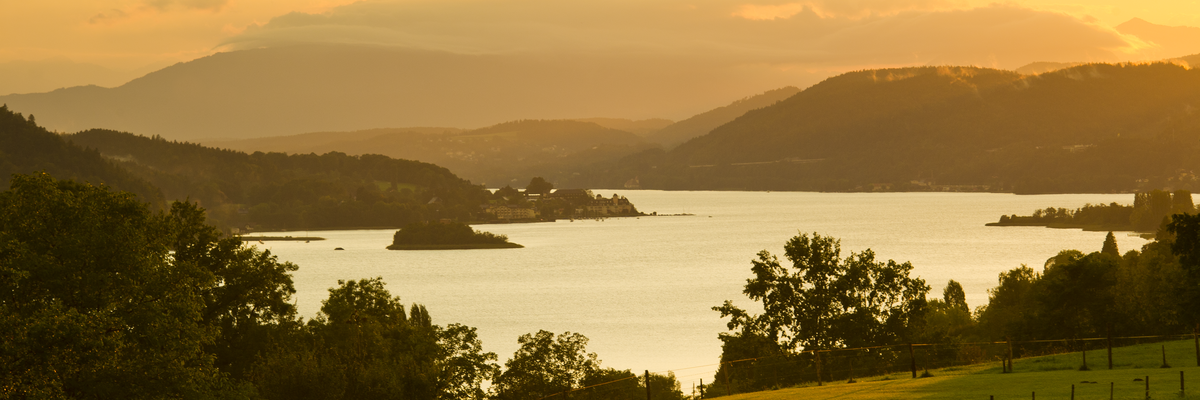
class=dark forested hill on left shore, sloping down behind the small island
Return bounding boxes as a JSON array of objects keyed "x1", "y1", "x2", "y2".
[{"x1": 67, "y1": 130, "x2": 490, "y2": 229}]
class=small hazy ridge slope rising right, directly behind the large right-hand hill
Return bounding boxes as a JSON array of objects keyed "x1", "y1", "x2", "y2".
[{"x1": 647, "y1": 86, "x2": 800, "y2": 149}]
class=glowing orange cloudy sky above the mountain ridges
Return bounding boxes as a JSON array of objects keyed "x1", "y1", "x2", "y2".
[{"x1": 0, "y1": 0, "x2": 1200, "y2": 94}]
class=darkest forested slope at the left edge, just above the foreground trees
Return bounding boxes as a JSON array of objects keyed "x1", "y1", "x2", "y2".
[{"x1": 0, "y1": 106, "x2": 164, "y2": 207}]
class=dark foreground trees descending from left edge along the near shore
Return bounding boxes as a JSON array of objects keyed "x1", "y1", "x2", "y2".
[{"x1": 0, "y1": 174, "x2": 682, "y2": 399}]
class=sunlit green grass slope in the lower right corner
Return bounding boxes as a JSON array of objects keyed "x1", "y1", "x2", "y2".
[{"x1": 712, "y1": 340, "x2": 1200, "y2": 400}]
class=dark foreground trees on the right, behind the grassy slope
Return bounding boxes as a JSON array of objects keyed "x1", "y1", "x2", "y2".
[{"x1": 706, "y1": 216, "x2": 1200, "y2": 394}]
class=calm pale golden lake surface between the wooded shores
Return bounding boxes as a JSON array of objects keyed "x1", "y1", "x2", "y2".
[{"x1": 248, "y1": 190, "x2": 1146, "y2": 393}]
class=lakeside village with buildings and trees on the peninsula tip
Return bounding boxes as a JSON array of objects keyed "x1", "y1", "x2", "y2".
[{"x1": 480, "y1": 186, "x2": 654, "y2": 222}]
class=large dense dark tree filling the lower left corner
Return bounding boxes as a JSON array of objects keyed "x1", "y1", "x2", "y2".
[{"x1": 0, "y1": 174, "x2": 233, "y2": 399}]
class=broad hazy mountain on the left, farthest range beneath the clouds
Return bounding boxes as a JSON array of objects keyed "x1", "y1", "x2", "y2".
[{"x1": 0, "y1": 44, "x2": 806, "y2": 141}]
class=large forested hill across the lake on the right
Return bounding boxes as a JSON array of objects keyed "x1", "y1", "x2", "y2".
[{"x1": 592, "y1": 64, "x2": 1200, "y2": 192}]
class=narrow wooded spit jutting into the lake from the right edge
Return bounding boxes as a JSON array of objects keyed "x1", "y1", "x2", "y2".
[{"x1": 989, "y1": 190, "x2": 1195, "y2": 232}]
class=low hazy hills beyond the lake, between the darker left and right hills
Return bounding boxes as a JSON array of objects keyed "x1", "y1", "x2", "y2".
[{"x1": 204, "y1": 86, "x2": 799, "y2": 186}]
